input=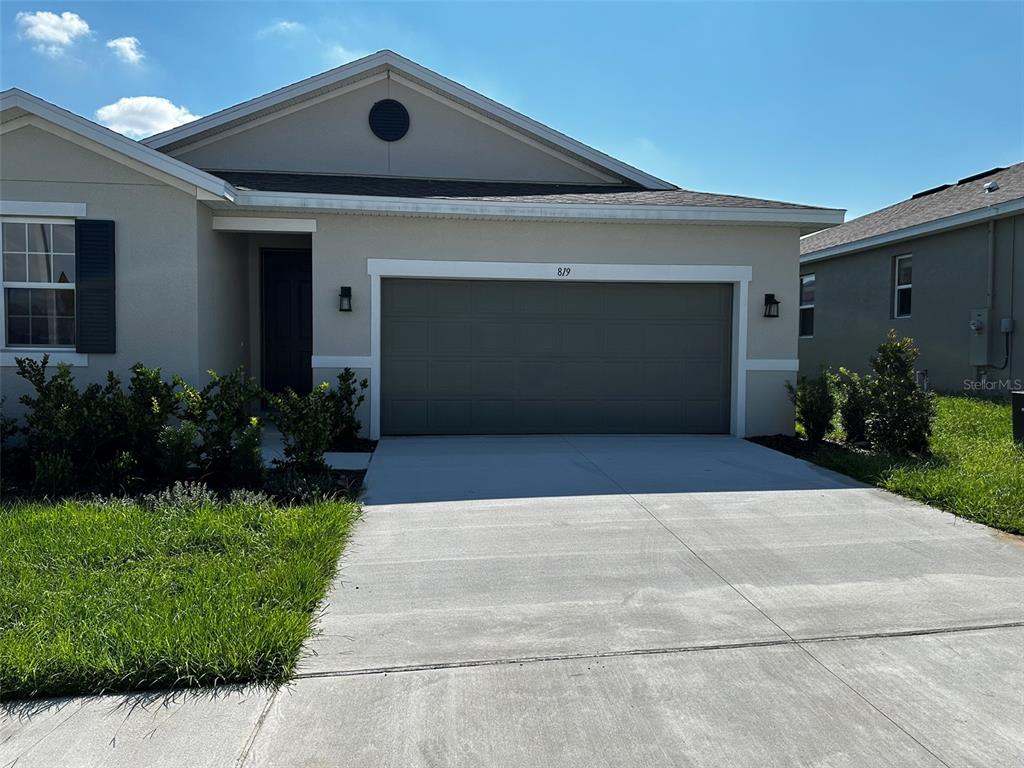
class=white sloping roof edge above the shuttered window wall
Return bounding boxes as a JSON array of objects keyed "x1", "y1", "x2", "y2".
[{"x1": 0, "y1": 88, "x2": 233, "y2": 200}]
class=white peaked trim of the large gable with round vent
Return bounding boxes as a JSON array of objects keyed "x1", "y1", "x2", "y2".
[{"x1": 143, "y1": 50, "x2": 673, "y2": 189}]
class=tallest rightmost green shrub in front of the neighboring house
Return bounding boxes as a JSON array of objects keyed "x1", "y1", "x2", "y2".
[{"x1": 867, "y1": 331, "x2": 935, "y2": 456}]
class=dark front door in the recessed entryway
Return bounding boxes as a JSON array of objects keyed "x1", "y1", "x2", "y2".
[{"x1": 262, "y1": 250, "x2": 313, "y2": 394}]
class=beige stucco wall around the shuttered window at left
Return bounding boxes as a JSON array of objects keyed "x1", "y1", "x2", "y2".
[{"x1": 0, "y1": 126, "x2": 200, "y2": 407}]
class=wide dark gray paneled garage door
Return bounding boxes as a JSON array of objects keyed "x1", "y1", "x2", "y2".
[{"x1": 381, "y1": 279, "x2": 732, "y2": 434}]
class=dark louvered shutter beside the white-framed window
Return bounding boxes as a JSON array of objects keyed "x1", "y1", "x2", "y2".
[{"x1": 75, "y1": 219, "x2": 117, "y2": 352}]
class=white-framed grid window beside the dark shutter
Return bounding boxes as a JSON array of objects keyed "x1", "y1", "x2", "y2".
[{"x1": 3, "y1": 221, "x2": 75, "y2": 347}]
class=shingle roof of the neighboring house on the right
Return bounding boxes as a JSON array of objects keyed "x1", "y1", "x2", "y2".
[{"x1": 800, "y1": 163, "x2": 1024, "y2": 256}]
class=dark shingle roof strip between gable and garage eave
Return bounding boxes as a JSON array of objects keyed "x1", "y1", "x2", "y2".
[{"x1": 209, "y1": 171, "x2": 822, "y2": 210}]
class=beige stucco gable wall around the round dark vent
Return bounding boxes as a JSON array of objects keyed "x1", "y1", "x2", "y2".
[{"x1": 164, "y1": 72, "x2": 620, "y2": 183}]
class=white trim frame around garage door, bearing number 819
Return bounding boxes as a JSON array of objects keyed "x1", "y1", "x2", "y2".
[{"x1": 367, "y1": 259, "x2": 754, "y2": 440}]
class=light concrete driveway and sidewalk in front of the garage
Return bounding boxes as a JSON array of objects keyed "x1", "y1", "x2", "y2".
[{"x1": 0, "y1": 436, "x2": 1024, "y2": 768}]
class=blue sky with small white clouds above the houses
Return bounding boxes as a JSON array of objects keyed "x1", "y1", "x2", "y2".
[{"x1": 0, "y1": 0, "x2": 1024, "y2": 218}]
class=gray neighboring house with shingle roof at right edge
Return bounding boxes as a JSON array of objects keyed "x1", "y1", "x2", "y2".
[{"x1": 800, "y1": 163, "x2": 1024, "y2": 394}]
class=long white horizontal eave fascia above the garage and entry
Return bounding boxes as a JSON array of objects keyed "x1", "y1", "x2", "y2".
[{"x1": 214, "y1": 190, "x2": 844, "y2": 229}]
